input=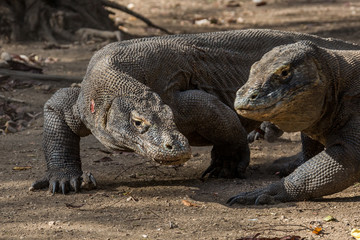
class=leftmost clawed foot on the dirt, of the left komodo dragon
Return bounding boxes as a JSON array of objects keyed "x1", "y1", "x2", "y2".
[{"x1": 29, "y1": 170, "x2": 96, "y2": 194}]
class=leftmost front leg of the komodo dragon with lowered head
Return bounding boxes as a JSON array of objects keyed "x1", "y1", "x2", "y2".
[{"x1": 31, "y1": 88, "x2": 96, "y2": 193}]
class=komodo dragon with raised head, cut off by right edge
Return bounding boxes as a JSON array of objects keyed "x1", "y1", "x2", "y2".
[{"x1": 229, "y1": 41, "x2": 360, "y2": 204}]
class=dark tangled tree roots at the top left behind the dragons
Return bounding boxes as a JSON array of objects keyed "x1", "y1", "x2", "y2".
[{"x1": 0, "y1": 0, "x2": 171, "y2": 44}]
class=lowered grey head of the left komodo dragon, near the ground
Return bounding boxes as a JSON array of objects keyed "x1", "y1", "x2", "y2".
[{"x1": 93, "y1": 93, "x2": 191, "y2": 165}]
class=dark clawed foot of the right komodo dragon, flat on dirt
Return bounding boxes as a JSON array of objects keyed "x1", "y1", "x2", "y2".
[{"x1": 227, "y1": 181, "x2": 293, "y2": 205}]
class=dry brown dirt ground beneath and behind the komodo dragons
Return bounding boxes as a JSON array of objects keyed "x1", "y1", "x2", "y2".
[{"x1": 0, "y1": 0, "x2": 360, "y2": 240}]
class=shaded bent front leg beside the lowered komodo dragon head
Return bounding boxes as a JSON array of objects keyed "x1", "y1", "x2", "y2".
[{"x1": 171, "y1": 90, "x2": 250, "y2": 178}]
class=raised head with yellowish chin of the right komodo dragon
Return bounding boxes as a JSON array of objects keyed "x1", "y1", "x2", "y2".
[{"x1": 234, "y1": 41, "x2": 328, "y2": 131}]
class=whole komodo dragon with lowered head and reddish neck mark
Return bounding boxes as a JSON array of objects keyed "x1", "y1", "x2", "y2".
[{"x1": 32, "y1": 30, "x2": 358, "y2": 193}]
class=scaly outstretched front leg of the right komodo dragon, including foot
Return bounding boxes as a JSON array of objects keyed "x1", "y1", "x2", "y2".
[{"x1": 228, "y1": 119, "x2": 360, "y2": 205}]
